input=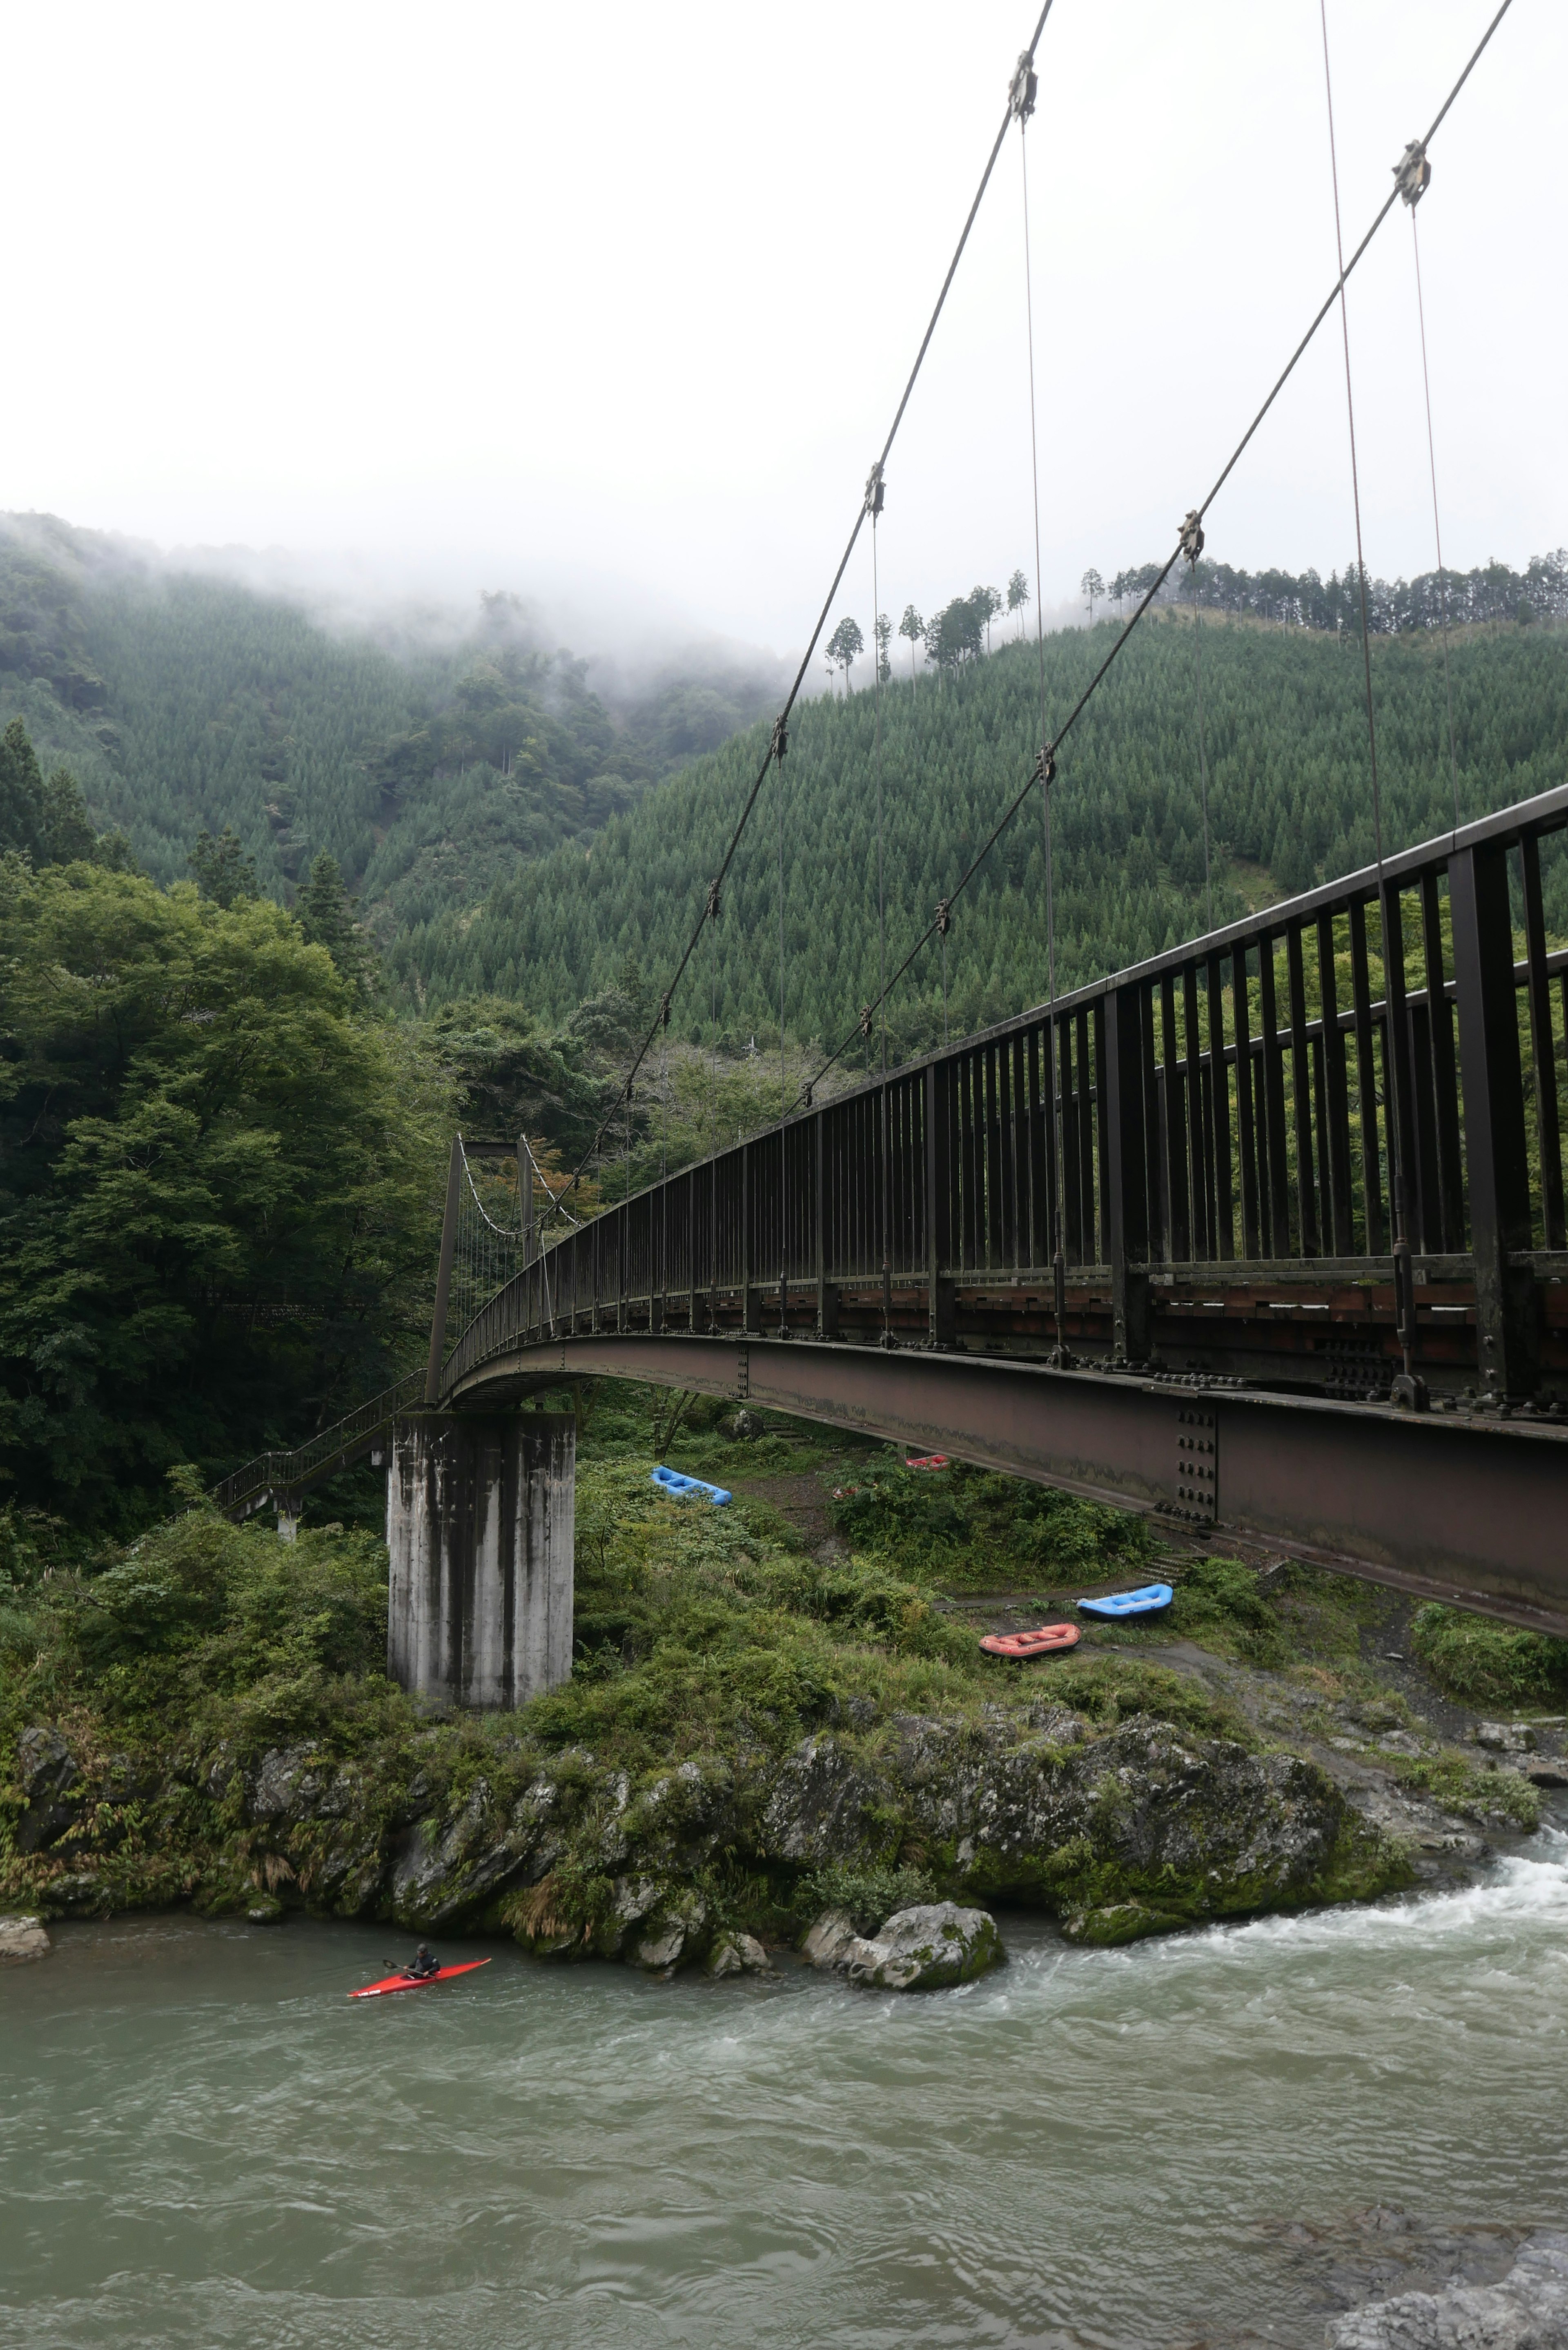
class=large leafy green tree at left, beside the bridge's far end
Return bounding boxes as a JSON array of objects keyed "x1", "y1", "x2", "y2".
[{"x1": 0, "y1": 860, "x2": 451, "y2": 1525}]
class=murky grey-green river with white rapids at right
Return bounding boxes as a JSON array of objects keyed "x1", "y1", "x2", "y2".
[{"x1": 0, "y1": 1828, "x2": 1568, "y2": 2350}]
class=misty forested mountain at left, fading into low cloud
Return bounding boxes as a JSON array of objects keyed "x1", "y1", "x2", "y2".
[{"x1": 0, "y1": 517, "x2": 771, "y2": 938}]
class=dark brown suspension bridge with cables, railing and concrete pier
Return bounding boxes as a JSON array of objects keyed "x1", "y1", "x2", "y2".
[{"x1": 218, "y1": 0, "x2": 1568, "y2": 1704}]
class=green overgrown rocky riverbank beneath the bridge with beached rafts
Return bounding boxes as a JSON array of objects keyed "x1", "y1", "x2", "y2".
[{"x1": 0, "y1": 1389, "x2": 1561, "y2": 1974}]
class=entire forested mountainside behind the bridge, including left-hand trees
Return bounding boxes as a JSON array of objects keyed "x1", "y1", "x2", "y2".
[{"x1": 0, "y1": 529, "x2": 1568, "y2": 1530}]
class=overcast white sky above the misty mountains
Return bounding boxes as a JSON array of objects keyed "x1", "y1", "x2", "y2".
[{"x1": 0, "y1": 0, "x2": 1568, "y2": 651}]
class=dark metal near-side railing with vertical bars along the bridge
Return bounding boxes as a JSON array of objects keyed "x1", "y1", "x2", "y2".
[{"x1": 442, "y1": 787, "x2": 1568, "y2": 1394}]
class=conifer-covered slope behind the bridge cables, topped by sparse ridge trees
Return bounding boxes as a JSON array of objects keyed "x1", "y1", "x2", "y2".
[{"x1": 390, "y1": 609, "x2": 1568, "y2": 1048}]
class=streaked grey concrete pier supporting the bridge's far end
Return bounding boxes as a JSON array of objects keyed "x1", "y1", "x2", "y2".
[{"x1": 385, "y1": 1412, "x2": 576, "y2": 1708}]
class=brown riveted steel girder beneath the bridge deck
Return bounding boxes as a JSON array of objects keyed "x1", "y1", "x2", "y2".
[{"x1": 442, "y1": 1332, "x2": 1568, "y2": 1635}]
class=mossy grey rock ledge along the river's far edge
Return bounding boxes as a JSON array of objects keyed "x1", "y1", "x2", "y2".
[{"x1": 9, "y1": 1699, "x2": 1406, "y2": 1986}]
